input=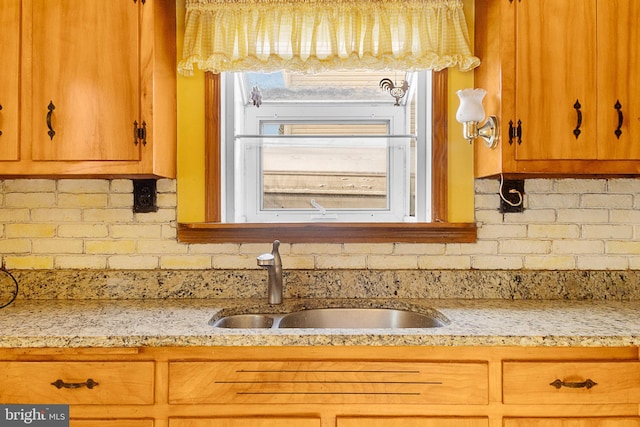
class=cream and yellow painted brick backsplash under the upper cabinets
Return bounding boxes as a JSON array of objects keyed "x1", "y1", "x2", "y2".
[{"x1": 0, "y1": 178, "x2": 640, "y2": 270}]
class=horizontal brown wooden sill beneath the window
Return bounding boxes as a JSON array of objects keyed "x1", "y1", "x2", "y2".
[{"x1": 178, "y1": 222, "x2": 477, "y2": 243}]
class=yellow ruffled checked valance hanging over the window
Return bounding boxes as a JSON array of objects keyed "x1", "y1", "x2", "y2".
[{"x1": 178, "y1": 0, "x2": 480, "y2": 75}]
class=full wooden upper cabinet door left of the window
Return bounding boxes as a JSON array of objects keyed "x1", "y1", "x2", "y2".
[{"x1": 30, "y1": 0, "x2": 140, "y2": 160}]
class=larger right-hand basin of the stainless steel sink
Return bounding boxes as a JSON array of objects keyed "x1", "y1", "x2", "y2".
[{"x1": 278, "y1": 308, "x2": 444, "y2": 329}]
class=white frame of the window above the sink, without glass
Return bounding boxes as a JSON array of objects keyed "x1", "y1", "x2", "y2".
[{"x1": 222, "y1": 72, "x2": 431, "y2": 223}]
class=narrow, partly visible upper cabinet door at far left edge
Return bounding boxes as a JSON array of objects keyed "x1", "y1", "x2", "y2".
[{"x1": 0, "y1": 0, "x2": 20, "y2": 160}]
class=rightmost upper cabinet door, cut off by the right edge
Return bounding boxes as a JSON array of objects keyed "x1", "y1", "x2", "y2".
[{"x1": 598, "y1": 0, "x2": 640, "y2": 160}]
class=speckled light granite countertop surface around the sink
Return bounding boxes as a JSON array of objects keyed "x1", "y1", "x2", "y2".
[{"x1": 0, "y1": 299, "x2": 640, "y2": 348}]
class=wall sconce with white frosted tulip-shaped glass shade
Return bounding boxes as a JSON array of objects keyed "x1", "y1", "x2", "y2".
[{"x1": 456, "y1": 89, "x2": 500, "y2": 148}]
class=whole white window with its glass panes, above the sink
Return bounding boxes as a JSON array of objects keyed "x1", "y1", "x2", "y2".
[{"x1": 222, "y1": 71, "x2": 431, "y2": 223}]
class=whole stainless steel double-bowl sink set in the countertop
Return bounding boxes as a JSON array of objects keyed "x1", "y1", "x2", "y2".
[{"x1": 213, "y1": 308, "x2": 447, "y2": 329}]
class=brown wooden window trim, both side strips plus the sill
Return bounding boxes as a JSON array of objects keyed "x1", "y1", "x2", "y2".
[{"x1": 178, "y1": 70, "x2": 476, "y2": 243}]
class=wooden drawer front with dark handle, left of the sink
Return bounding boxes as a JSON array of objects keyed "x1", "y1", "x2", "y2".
[{"x1": 0, "y1": 362, "x2": 154, "y2": 405}]
